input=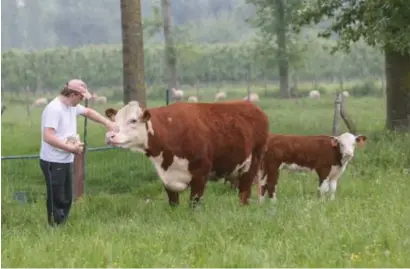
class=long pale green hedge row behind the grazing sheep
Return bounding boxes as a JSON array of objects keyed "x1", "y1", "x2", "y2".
[{"x1": 2, "y1": 43, "x2": 382, "y2": 91}]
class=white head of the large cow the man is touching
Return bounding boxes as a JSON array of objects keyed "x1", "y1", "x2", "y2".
[{"x1": 105, "y1": 101, "x2": 151, "y2": 150}]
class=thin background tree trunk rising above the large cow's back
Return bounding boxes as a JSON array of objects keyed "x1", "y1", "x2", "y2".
[{"x1": 161, "y1": 0, "x2": 177, "y2": 89}]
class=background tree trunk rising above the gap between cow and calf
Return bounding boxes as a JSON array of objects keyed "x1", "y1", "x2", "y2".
[{"x1": 276, "y1": 0, "x2": 289, "y2": 98}]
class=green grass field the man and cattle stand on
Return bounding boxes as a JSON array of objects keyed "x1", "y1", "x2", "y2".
[{"x1": 1, "y1": 87, "x2": 410, "y2": 267}]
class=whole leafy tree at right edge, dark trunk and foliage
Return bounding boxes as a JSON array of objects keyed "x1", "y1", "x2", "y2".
[{"x1": 298, "y1": 0, "x2": 410, "y2": 131}]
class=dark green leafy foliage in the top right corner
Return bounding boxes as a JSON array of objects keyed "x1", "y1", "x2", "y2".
[{"x1": 294, "y1": 0, "x2": 410, "y2": 52}]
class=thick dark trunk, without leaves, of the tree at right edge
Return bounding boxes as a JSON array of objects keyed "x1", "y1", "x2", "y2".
[{"x1": 385, "y1": 49, "x2": 410, "y2": 132}]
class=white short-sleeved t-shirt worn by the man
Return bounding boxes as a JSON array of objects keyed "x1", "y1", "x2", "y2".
[{"x1": 40, "y1": 97, "x2": 85, "y2": 163}]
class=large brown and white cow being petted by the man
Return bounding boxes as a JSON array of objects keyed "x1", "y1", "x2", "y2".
[{"x1": 105, "y1": 101, "x2": 269, "y2": 206}]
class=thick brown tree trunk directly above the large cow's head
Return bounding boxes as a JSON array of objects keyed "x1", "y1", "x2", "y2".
[{"x1": 121, "y1": 0, "x2": 147, "y2": 107}]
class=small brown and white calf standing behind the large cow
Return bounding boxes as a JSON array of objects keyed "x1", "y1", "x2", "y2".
[{"x1": 259, "y1": 133, "x2": 367, "y2": 201}]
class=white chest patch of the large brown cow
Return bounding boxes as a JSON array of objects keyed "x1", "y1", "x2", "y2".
[{"x1": 151, "y1": 152, "x2": 192, "y2": 192}]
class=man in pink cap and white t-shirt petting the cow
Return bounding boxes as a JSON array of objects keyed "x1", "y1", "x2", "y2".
[{"x1": 40, "y1": 79, "x2": 115, "y2": 226}]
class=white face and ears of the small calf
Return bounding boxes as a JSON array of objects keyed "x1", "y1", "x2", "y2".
[{"x1": 331, "y1": 133, "x2": 367, "y2": 160}]
